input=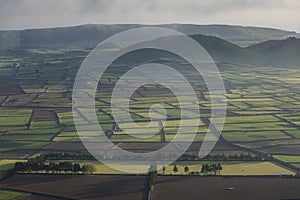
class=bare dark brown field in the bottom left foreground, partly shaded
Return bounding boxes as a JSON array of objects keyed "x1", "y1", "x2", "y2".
[{"x1": 0, "y1": 175, "x2": 147, "y2": 200}]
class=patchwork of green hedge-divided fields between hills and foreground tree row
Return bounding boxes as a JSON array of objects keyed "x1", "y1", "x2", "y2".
[{"x1": 0, "y1": 50, "x2": 300, "y2": 174}]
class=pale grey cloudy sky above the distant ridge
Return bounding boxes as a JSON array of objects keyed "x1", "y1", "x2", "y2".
[{"x1": 0, "y1": 0, "x2": 300, "y2": 32}]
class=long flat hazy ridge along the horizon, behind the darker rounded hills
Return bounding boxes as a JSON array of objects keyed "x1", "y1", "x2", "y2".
[{"x1": 0, "y1": 24, "x2": 300, "y2": 50}]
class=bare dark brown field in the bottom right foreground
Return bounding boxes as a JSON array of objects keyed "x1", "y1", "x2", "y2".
[{"x1": 150, "y1": 176, "x2": 300, "y2": 200}]
